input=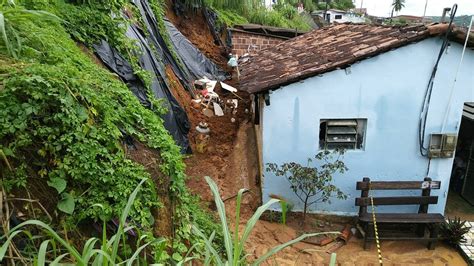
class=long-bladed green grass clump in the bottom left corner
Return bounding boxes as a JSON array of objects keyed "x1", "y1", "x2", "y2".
[{"x1": 0, "y1": 179, "x2": 166, "y2": 266}]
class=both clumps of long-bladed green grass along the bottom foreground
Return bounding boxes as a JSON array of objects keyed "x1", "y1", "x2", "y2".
[{"x1": 0, "y1": 177, "x2": 340, "y2": 266}]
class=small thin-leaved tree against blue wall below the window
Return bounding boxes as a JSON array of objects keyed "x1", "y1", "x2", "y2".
[{"x1": 267, "y1": 150, "x2": 348, "y2": 221}]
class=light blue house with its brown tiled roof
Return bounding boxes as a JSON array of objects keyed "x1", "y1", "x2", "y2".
[{"x1": 240, "y1": 24, "x2": 474, "y2": 215}]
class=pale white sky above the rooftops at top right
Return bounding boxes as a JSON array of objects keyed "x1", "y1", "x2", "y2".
[{"x1": 355, "y1": 0, "x2": 474, "y2": 16}]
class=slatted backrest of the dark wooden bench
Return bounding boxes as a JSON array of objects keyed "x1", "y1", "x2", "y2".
[{"x1": 355, "y1": 177, "x2": 441, "y2": 214}]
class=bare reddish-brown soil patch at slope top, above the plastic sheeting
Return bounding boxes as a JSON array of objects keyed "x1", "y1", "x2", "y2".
[{"x1": 166, "y1": 0, "x2": 228, "y2": 70}]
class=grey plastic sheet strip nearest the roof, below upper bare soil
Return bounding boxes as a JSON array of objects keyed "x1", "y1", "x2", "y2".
[{"x1": 165, "y1": 19, "x2": 227, "y2": 80}]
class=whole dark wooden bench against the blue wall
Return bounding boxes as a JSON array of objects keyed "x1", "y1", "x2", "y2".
[{"x1": 355, "y1": 177, "x2": 444, "y2": 250}]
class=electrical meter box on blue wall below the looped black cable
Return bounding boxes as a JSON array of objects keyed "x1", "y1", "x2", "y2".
[{"x1": 428, "y1": 133, "x2": 458, "y2": 158}]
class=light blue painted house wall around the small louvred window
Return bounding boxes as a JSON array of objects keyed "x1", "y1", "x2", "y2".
[{"x1": 262, "y1": 38, "x2": 474, "y2": 215}]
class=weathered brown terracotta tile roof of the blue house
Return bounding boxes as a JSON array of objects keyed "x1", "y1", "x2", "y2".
[{"x1": 240, "y1": 24, "x2": 456, "y2": 93}]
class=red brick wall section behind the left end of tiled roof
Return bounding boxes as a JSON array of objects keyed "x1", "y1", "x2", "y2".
[{"x1": 232, "y1": 31, "x2": 285, "y2": 56}]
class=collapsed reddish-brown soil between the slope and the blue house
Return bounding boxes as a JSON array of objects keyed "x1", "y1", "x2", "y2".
[{"x1": 166, "y1": 62, "x2": 254, "y2": 204}]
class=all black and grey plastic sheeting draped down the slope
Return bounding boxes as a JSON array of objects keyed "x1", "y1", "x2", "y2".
[{"x1": 94, "y1": 0, "x2": 226, "y2": 152}]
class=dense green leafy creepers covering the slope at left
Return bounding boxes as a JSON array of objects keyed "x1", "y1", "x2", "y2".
[{"x1": 0, "y1": 0, "x2": 220, "y2": 260}]
